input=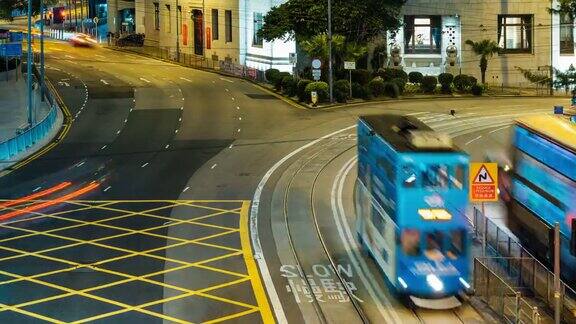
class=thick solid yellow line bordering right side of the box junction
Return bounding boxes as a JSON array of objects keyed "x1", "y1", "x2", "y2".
[{"x1": 240, "y1": 201, "x2": 275, "y2": 323}]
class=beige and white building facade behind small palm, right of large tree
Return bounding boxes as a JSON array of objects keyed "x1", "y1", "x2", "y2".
[{"x1": 389, "y1": 0, "x2": 576, "y2": 86}]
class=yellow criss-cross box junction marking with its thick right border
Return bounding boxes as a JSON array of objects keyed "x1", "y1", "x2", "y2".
[{"x1": 0, "y1": 200, "x2": 274, "y2": 323}]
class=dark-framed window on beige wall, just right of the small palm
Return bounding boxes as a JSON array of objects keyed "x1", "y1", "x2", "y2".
[{"x1": 498, "y1": 15, "x2": 532, "y2": 53}]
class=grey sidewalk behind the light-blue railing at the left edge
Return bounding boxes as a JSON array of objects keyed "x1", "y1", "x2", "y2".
[{"x1": 0, "y1": 76, "x2": 50, "y2": 143}]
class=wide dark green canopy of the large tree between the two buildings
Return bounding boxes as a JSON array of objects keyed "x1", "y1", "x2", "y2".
[{"x1": 258, "y1": 0, "x2": 406, "y2": 45}]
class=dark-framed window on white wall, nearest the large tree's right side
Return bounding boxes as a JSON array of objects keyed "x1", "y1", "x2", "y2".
[{"x1": 404, "y1": 16, "x2": 442, "y2": 54}]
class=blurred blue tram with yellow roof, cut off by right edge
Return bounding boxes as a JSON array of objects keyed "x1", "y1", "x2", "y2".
[{"x1": 507, "y1": 116, "x2": 576, "y2": 287}]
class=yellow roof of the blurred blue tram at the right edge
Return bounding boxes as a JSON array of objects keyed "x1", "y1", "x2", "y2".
[{"x1": 516, "y1": 115, "x2": 576, "y2": 152}]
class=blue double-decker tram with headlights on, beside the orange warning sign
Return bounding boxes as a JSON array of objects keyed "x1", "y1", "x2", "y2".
[{"x1": 356, "y1": 115, "x2": 471, "y2": 308}]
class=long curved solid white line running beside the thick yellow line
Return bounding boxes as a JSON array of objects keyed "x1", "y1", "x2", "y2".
[{"x1": 250, "y1": 125, "x2": 356, "y2": 324}]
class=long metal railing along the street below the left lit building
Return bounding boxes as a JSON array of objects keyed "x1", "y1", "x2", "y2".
[{"x1": 110, "y1": 41, "x2": 265, "y2": 82}]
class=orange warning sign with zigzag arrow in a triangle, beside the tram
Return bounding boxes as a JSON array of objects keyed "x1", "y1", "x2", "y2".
[{"x1": 470, "y1": 163, "x2": 498, "y2": 202}]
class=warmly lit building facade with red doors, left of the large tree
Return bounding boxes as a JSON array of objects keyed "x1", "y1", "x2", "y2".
[{"x1": 108, "y1": 0, "x2": 295, "y2": 71}]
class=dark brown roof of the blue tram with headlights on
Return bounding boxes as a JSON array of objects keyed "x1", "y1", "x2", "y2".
[{"x1": 359, "y1": 114, "x2": 460, "y2": 152}]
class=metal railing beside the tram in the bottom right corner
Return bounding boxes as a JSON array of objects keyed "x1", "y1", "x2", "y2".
[{"x1": 472, "y1": 208, "x2": 576, "y2": 323}]
